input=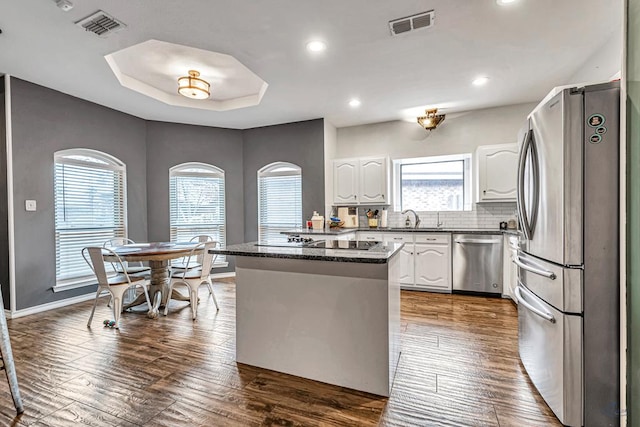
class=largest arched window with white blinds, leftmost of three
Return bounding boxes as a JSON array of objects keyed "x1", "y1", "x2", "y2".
[{"x1": 53, "y1": 148, "x2": 127, "y2": 286}]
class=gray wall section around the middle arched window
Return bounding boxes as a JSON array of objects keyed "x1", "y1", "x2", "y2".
[{"x1": 147, "y1": 122, "x2": 244, "y2": 272}]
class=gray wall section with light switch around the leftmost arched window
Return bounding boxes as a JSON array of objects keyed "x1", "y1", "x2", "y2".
[{"x1": 11, "y1": 78, "x2": 147, "y2": 310}]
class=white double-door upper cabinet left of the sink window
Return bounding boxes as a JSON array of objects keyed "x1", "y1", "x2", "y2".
[{"x1": 333, "y1": 157, "x2": 390, "y2": 205}]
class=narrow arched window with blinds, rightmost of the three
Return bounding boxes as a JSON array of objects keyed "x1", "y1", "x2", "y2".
[{"x1": 258, "y1": 162, "x2": 302, "y2": 240}]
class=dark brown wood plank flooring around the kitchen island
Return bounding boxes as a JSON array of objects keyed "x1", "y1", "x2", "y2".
[{"x1": 0, "y1": 280, "x2": 560, "y2": 427}]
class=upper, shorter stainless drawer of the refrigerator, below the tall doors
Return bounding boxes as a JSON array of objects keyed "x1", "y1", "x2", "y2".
[{"x1": 514, "y1": 251, "x2": 583, "y2": 314}]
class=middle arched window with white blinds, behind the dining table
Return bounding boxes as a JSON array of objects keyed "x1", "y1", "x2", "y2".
[{"x1": 169, "y1": 162, "x2": 227, "y2": 251}]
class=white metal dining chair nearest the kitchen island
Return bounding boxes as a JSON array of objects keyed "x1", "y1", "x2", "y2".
[{"x1": 164, "y1": 242, "x2": 220, "y2": 320}]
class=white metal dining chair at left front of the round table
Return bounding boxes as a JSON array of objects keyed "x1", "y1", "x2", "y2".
[{"x1": 82, "y1": 246, "x2": 151, "y2": 329}]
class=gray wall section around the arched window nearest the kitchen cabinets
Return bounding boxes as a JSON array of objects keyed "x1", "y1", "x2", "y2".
[{"x1": 243, "y1": 119, "x2": 325, "y2": 241}]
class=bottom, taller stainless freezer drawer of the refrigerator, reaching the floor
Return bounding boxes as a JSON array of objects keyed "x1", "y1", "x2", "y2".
[{"x1": 516, "y1": 284, "x2": 583, "y2": 426}]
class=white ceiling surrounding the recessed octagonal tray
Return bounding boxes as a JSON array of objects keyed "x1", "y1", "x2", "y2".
[{"x1": 0, "y1": 0, "x2": 623, "y2": 129}]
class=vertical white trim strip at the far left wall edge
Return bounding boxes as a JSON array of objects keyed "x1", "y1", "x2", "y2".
[{"x1": 4, "y1": 74, "x2": 16, "y2": 312}]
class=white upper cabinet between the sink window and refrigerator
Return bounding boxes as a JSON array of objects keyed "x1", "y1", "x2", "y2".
[{"x1": 476, "y1": 144, "x2": 518, "y2": 202}]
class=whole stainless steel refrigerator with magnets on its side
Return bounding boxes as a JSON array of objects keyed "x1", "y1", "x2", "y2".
[{"x1": 514, "y1": 82, "x2": 620, "y2": 427}]
